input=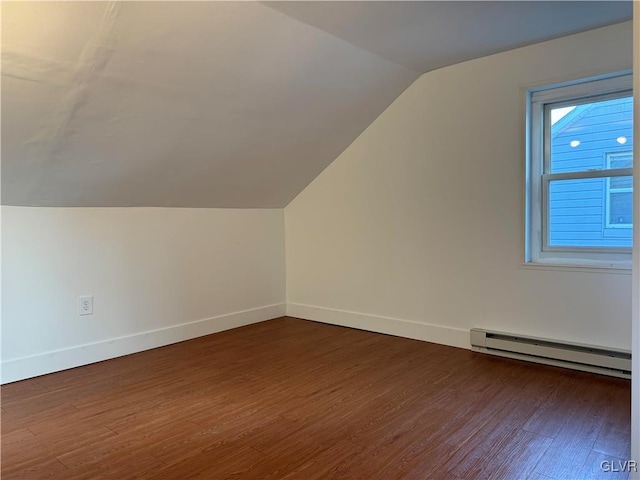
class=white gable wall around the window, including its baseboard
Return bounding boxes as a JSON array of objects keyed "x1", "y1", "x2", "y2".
[{"x1": 285, "y1": 22, "x2": 632, "y2": 349}]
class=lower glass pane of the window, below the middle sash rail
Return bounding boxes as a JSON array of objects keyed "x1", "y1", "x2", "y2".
[{"x1": 547, "y1": 177, "x2": 633, "y2": 248}]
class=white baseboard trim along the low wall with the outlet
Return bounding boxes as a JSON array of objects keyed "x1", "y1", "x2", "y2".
[{"x1": 1, "y1": 303, "x2": 286, "y2": 384}]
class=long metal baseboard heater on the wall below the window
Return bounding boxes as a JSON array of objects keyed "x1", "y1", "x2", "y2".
[{"x1": 471, "y1": 328, "x2": 631, "y2": 378}]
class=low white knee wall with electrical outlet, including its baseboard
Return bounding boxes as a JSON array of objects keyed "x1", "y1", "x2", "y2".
[{"x1": 2, "y1": 206, "x2": 285, "y2": 382}]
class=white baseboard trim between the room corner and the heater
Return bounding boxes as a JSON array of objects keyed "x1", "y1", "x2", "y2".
[{"x1": 287, "y1": 303, "x2": 471, "y2": 350}]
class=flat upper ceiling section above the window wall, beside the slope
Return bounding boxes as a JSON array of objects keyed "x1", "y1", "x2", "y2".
[{"x1": 265, "y1": 0, "x2": 632, "y2": 73}]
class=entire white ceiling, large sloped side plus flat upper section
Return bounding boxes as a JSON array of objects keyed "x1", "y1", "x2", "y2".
[{"x1": 2, "y1": 2, "x2": 631, "y2": 208}]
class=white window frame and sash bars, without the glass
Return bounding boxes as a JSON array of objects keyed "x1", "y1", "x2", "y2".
[{"x1": 525, "y1": 72, "x2": 633, "y2": 268}]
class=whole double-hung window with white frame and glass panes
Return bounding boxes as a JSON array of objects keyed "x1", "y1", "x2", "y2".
[{"x1": 526, "y1": 75, "x2": 633, "y2": 267}]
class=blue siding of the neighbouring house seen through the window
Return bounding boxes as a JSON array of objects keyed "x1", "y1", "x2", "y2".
[{"x1": 548, "y1": 98, "x2": 633, "y2": 247}]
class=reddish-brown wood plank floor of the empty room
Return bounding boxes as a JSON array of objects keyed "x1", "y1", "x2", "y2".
[{"x1": 2, "y1": 318, "x2": 630, "y2": 480}]
